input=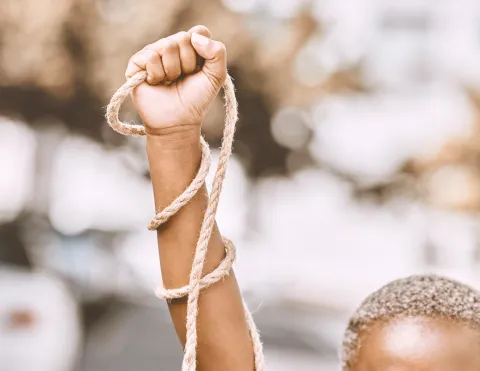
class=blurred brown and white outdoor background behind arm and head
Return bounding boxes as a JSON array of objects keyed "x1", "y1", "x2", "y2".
[{"x1": 0, "y1": 0, "x2": 480, "y2": 371}]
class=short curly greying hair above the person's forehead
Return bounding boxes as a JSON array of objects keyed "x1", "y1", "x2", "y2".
[{"x1": 340, "y1": 275, "x2": 480, "y2": 371}]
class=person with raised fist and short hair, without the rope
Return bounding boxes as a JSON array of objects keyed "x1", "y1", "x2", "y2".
[{"x1": 125, "y1": 26, "x2": 480, "y2": 371}]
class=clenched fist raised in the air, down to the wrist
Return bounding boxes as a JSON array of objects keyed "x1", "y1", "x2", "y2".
[{"x1": 125, "y1": 26, "x2": 227, "y2": 136}]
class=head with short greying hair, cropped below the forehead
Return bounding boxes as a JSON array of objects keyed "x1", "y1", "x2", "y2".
[{"x1": 341, "y1": 275, "x2": 480, "y2": 371}]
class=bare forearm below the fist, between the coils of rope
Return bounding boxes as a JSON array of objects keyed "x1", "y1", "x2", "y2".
[{"x1": 147, "y1": 133, "x2": 253, "y2": 371}]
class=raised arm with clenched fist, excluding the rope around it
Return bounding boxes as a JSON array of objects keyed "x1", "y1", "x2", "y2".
[{"x1": 126, "y1": 26, "x2": 254, "y2": 371}]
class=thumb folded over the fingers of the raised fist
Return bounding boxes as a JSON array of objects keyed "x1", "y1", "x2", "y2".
[{"x1": 192, "y1": 33, "x2": 227, "y2": 88}]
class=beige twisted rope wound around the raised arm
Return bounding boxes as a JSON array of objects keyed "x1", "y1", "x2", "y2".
[{"x1": 106, "y1": 71, "x2": 266, "y2": 371}]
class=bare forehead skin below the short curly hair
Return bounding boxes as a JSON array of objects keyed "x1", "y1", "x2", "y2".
[{"x1": 351, "y1": 317, "x2": 480, "y2": 371}]
